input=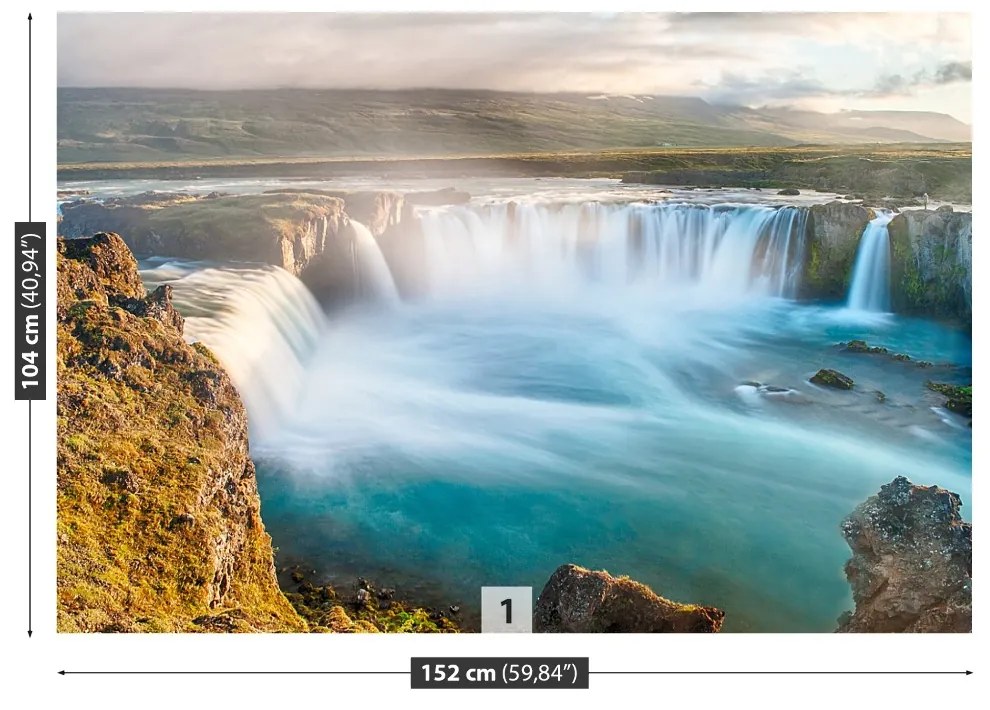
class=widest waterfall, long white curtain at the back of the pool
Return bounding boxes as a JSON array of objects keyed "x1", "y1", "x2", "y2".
[{"x1": 420, "y1": 202, "x2": 807, "y2": 297}]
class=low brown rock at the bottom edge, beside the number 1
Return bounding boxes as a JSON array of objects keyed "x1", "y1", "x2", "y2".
[{"x1": 533, "y1": 565, "x2": 725, "y2": 633}]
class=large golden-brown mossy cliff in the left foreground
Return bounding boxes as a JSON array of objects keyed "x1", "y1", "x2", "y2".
[{"x1": 57, "y1": 233, "x2": 306, "y2": 631}]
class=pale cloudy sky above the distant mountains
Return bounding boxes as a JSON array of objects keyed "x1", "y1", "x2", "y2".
[{"x1": 58, "y1": 13, "x2": 972, "y2": 122}]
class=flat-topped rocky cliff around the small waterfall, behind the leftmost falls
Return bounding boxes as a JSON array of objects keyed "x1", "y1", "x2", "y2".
[{"x1": 59, "y1": 188, "x2": 450, "y2": 308}]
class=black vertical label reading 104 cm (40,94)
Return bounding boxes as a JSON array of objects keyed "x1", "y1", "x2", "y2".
[{"x1": 14, "y1": 222, "x2": 47, "y2": 399}]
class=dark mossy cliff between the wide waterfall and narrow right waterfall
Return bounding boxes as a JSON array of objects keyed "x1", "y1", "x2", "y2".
[{"x1": 800, "y1": 202, "x2": 876, "y2": 300}]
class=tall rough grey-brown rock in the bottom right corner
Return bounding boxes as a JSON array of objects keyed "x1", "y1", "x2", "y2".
[{"x1": 838, "y1": 476, "x2": 973, "y2": 633}]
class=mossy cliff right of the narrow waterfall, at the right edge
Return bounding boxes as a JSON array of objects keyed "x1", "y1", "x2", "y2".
[{"x1": 887, "y1": 208, "x2": 973, "y2": 323}]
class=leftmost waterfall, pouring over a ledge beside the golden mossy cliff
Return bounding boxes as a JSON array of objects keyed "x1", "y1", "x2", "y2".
[{"x1": 149, "y1": 262, "x2": 325, "y2": 437}]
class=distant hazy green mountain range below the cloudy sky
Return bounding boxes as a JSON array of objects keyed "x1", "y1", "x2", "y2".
[{"x1": 58, "y1": 88, "x2": 971, "y2": 164}]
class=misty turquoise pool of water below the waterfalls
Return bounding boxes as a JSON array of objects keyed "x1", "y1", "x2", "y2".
[{"x1": 253, "y1": 293, "x2": 971, "y2": 632}]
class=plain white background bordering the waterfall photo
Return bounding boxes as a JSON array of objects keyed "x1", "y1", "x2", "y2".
[{"x1": 0, "y1": 0, "x2": 990, "y2": 710}]
